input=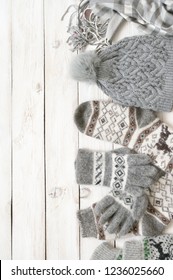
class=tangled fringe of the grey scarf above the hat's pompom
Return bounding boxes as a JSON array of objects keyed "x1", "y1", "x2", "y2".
[{"x1": 61, "y1": 0, "x2": 110, "y2": 51}]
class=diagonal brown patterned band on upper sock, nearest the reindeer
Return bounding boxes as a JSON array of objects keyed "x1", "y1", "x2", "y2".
[{"x1": 133, "y1": 120, "x2": 162, "y2": 151}]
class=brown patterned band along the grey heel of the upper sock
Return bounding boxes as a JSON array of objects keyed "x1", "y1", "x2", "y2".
[{"x1": 123, "y1": 107, "x2": 137, "y2": 146}]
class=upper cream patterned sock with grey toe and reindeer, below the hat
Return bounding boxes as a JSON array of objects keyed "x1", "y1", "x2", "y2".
[{"x1": 74, "y1": 101, "x2": 173, "y2": 174}]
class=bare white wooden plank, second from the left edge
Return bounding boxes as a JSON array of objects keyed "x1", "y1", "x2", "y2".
[{"x1": 12, "y1": 0, "x2": 45, "y2": 260}]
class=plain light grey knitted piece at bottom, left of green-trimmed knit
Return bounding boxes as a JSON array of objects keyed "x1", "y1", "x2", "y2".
[{"x1": 90, "y1": 242, "x2": 123, "y2": 260}]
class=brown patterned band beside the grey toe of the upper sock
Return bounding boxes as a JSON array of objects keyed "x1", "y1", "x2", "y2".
[{"x1": 86, "y1": 101, "x2": 100, "y2": 136}]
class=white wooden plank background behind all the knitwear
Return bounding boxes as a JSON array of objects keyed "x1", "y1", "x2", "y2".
[{"x1": 0, "y1": 0, "x2": 173, "y2": 260}]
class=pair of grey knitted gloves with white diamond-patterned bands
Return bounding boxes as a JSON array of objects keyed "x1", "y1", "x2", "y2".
[{"x1": 75, "y1": 148, "x2": 163, "y2": 239}]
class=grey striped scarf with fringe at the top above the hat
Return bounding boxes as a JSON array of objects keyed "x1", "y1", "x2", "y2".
[{"x1": 62, "y1": 0, "x2": 173, "y2": 51}]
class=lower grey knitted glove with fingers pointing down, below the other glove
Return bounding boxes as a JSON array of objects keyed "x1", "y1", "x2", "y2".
[{"x1": 77, "y1": 193, "x2": 148, "y2": 240}]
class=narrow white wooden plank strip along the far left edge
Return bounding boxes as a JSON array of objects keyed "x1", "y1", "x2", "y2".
[{"x1": 0, "y1": 0, "x2": 11, "y2": 260}]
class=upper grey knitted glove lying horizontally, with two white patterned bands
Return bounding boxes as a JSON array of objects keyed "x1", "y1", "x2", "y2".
[{"x1": 75, "y1": 148, "x2": 164, "y2": 196}]
